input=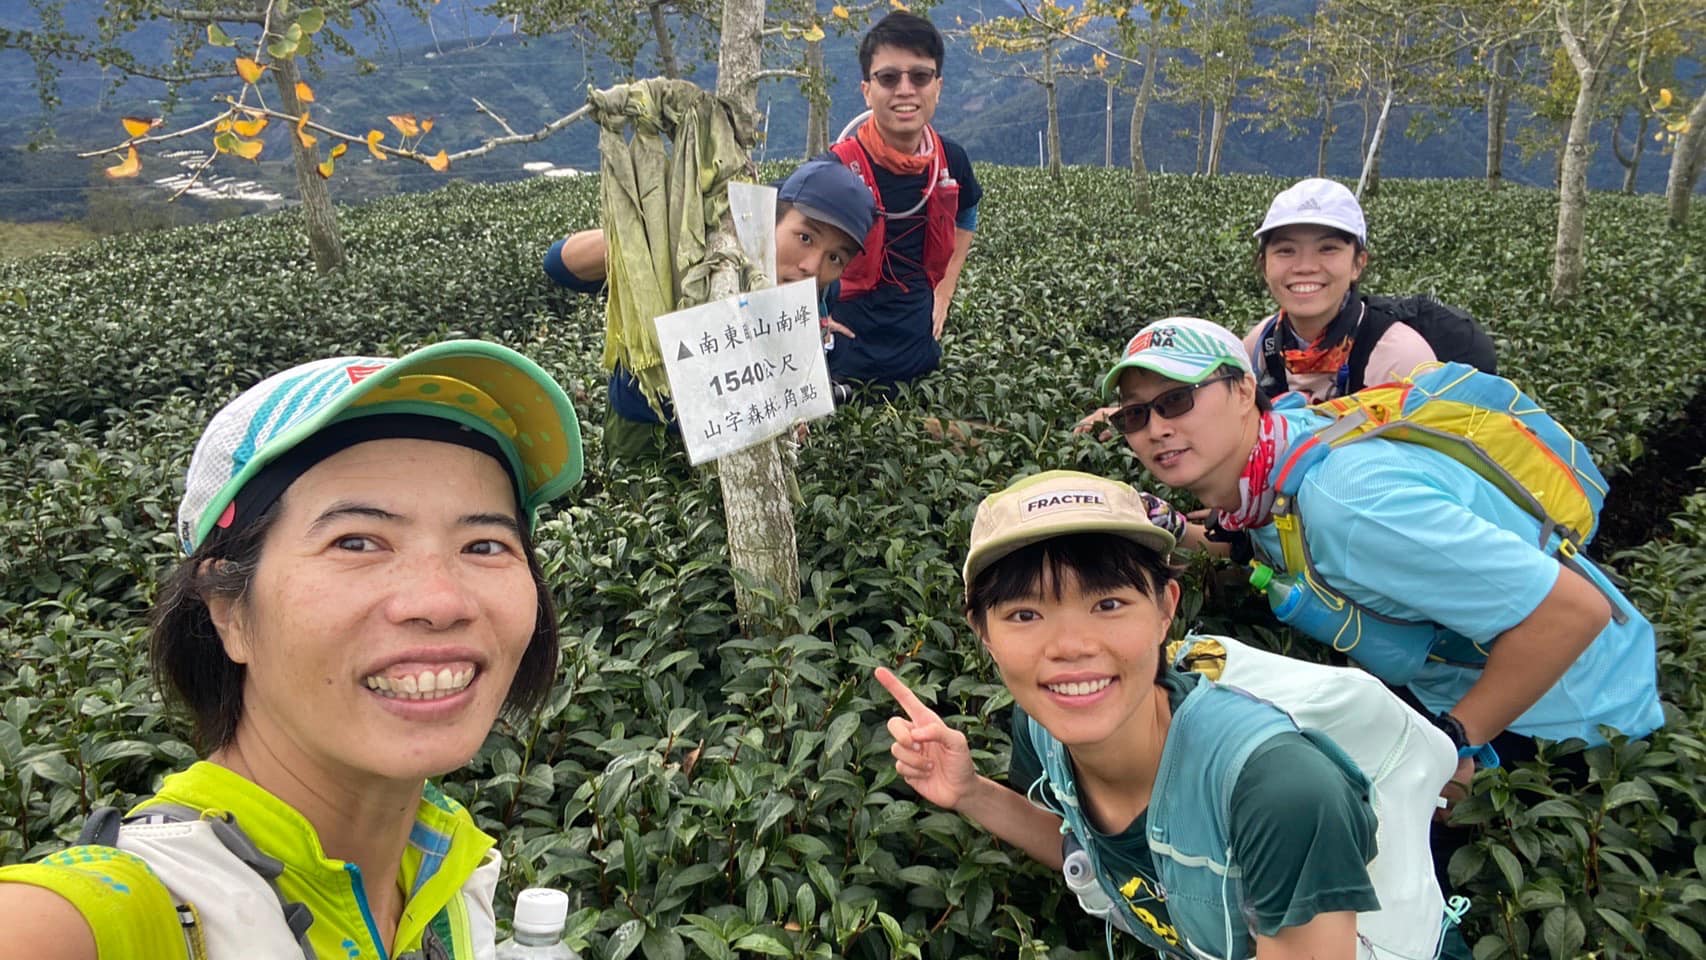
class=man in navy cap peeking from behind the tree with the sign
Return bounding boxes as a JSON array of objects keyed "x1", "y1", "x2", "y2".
[{"x1": 544, "y1": 160, "x2": 877, "y2": 459}]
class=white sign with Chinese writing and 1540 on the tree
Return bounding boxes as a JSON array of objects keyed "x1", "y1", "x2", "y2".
[{"x1": 657, "y1": 280, "x2": 834, "y2": 466}]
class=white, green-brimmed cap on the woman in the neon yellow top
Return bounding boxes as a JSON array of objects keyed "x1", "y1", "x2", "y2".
[{"x1": 177, "y1": 339, "x2": 583, "y2": 554}]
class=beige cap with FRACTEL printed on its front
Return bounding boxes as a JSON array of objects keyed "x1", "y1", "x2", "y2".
[{"x1": 964, "y1": 471, "x2": 1174, "y2": 592}]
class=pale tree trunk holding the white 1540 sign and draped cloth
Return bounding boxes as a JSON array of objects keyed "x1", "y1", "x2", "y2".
[{"x1": 706, "y1": 0, "x2": 800, "y2": 613}]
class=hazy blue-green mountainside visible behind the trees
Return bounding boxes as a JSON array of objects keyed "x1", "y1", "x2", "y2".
[{"x1": 0, "y1": 0, "x2": 1668, "y2": 220}]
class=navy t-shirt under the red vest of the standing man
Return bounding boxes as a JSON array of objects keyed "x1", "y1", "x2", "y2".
[{"x1": 829, "y1": 140, "x2": 983, "y2": 384}]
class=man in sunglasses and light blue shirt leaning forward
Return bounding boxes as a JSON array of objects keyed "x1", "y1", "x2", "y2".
[{"x1": 1102, "y1": 317, "x2": 1663, "y2": 818}]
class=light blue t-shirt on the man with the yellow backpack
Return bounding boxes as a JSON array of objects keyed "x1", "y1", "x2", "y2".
[{"x1": 1252, "y1": 411, "x2": 1665, "y2": 743}]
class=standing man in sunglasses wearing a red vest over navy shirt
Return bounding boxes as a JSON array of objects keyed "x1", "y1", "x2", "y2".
[{"x1": 827, "y1": 10, "x2": 983, "y2": 385}]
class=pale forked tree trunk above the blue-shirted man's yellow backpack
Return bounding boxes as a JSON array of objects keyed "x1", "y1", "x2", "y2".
[{"x1": 1551, "y1": 0, "x2": 1629, "y2": 304}]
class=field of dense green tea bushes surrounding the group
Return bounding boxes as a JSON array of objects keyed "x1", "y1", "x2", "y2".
[{"x1": 0, "y1": 169, "x2": 1706, "y2": 960}]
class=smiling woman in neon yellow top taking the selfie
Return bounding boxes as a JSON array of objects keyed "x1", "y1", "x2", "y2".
[{"x1": 0, "y1": 341, "x2": 582, "y2": 960}]
